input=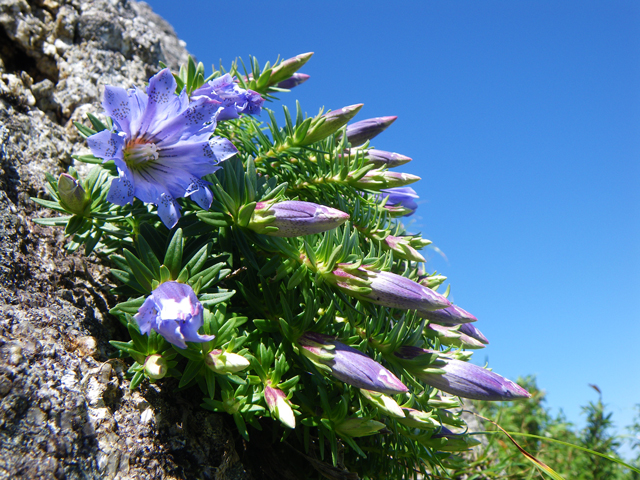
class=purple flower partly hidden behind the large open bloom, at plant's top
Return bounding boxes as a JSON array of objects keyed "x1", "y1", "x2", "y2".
[{"x1": 191, "y1": 73, "x2": 264, "y2": 121}]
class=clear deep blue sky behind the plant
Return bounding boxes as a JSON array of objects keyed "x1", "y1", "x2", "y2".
[{"x1": 148, "y1": 0, "x2": 640, "y2": 450}]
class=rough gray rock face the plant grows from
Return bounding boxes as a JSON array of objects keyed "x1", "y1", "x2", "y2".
[{"x1": 0, "y1": 0, "x2": 251, "y2": 480}]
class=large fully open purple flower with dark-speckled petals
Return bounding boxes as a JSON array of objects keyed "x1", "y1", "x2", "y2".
[{"x1": 87, "y1": 69, "x2": 237, "y2": 228}]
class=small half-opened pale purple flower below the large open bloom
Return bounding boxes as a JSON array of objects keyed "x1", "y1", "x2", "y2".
[{"x1": 133, "y1": 282, "x2": 215, "y2": 348}]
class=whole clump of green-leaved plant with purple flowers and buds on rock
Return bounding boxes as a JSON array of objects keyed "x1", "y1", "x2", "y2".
[{"x1": 35, "y1": 53, "x2": 529, "y2": 478}]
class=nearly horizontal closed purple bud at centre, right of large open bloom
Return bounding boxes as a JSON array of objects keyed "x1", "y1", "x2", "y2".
[{"x1": 247, "y1": 200, "x2": 349, "y2": 237}]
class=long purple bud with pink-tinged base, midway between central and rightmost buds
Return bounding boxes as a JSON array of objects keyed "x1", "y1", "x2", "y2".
[{"x1": 325, "y1": 264, "x2": 451, "y2": 314}]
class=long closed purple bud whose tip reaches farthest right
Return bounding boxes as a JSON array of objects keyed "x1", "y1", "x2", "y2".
[{"x1": 395, "y1": 346, "x2": 531, "y2": 401}]
